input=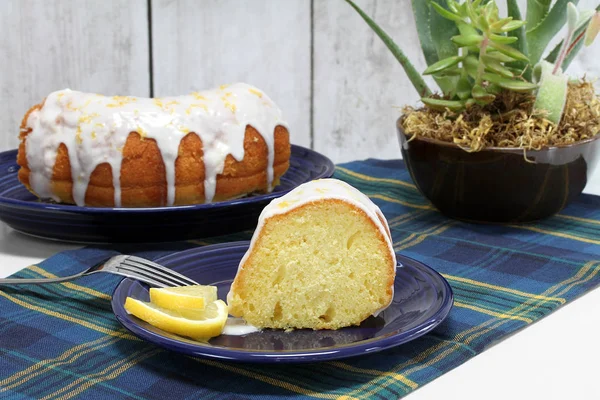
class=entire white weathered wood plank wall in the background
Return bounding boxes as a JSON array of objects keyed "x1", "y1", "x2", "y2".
[{"x1": 0, "y1": 0, "x2": 600, "y2": 162}]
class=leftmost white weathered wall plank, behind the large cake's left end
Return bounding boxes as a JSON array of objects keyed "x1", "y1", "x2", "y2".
[{"x1": 0, "y1": 0, "x2": 149, "y2": 150}]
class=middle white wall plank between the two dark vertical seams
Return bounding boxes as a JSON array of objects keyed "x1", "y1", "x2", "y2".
[{"x1": 152, "y1": 0, "x2": 310, "y2": 146}]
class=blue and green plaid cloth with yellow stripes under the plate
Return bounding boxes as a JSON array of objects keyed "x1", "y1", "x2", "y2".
[{"x1": 0, "y1": 159, "x2": 600, "y2": 399}]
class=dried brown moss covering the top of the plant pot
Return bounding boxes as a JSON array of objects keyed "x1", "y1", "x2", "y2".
[{"x1": 401, "y1": 80, "x2": 600, "y2": 151}]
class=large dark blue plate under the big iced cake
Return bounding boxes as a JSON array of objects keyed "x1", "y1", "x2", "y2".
[{"x1": 0, "y1": 145, "x2": 335, "y2": 243}]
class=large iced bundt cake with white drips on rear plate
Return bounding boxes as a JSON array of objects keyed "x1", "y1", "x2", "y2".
[{"x1": 17, "y1": 83, "x2": 290, "y2": 207}]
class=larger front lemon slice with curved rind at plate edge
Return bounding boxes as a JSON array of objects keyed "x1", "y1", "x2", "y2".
[{"x1": 125, "y1": 297, "x2": 227, "y2": 340}]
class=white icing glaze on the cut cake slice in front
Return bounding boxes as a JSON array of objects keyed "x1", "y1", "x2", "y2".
[{"x1": 227, "y1": 178, "x2": 396, "y2": 316}]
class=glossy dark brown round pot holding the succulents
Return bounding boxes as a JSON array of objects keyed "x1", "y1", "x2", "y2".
[{"x1": 397, "y1": 119, "x2": 600, "y2": 223}]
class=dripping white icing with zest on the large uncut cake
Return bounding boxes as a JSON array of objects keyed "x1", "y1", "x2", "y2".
[{"x1": 25, "y1": 83, "x2": 287, "y2": 207}]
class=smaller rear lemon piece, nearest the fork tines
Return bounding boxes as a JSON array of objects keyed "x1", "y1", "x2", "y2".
[{"x1": 150, "y1": 285, "x2": 217, "y2": 310}]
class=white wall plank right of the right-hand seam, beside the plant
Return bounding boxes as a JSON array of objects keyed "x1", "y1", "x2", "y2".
[{"x1": 314, "y1": 0, "x2": 425, "y2": 162}]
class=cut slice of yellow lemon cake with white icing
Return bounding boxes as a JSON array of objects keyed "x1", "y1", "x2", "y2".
[{"x1": 227, "y1": 179, "x2": 396, "y2": 329}]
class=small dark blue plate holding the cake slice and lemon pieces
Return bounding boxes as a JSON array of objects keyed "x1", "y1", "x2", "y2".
[{"x1": 112, "y1": 242, "x2": 452, "y2": 363}]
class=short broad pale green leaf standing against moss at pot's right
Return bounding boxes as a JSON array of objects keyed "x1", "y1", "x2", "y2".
[{"x1": 533, "y1": 61, "x2": 569, "y2": 124}]
